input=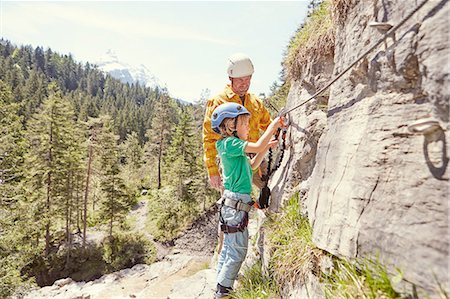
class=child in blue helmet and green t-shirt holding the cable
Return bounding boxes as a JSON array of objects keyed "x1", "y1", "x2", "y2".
[{"x1": 211, "y1": 103, "x2": 281, "y2": 298}]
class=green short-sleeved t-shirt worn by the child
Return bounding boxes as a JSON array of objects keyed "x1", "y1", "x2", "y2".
[{"x1": 216, "y1": 136, "x2": 253, "y2": 194}]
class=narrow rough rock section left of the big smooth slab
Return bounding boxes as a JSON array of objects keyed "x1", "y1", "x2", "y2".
[{"x1": 270, "y1": 57, "x2": 334, "y2": 211}]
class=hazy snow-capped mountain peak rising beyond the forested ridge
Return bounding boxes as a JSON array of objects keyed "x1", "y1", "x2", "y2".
[{"x1": 95, "y1": 49, "x2": 166, "y2": 88}]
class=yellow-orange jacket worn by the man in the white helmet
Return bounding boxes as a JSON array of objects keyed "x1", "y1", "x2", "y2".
[{"x1": 203, "y1": 84, "x2": 272, "y2": 177}]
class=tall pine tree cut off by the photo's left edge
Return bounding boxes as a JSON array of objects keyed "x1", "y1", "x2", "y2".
[{"x1": 0, "y1": 81, "x2": 33, "y2": 298}]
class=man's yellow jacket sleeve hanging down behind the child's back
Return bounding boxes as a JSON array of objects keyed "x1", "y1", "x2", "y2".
[{"x1": 202, "y1": 99, "x2": 220, "y2": 177}]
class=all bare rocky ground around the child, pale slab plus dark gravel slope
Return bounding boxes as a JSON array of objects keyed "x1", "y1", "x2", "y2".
[{"x1": 20, "y1": 201, "x2": 268, "y2": 299}]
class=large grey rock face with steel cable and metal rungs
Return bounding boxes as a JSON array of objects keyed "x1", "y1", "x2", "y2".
[{"x1": 271, "y1": 0, "x2": 450, "y2": 293}]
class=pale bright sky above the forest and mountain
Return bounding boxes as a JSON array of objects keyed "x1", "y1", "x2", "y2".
[{"x1": 0, "y1": 0, "x2": 309, "y2": 102}]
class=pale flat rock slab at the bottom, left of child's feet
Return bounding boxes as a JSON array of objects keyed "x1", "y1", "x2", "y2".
[{"x1": 25, "y1": 252, "x2": 215, "y2": 299}]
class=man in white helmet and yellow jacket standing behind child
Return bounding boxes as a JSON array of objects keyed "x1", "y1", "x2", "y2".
[{"x1": 203, "y1": 53, "x2": 271, "y2": 190}]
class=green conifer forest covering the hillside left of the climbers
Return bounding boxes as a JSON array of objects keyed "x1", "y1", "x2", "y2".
[{"x1": 0, "y1": 39, "x2": 220, "y2": 298}]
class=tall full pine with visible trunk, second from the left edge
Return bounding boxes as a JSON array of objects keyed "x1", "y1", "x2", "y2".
[{"x1": 26, "y1": 83, "x2": 76, "y2": 255}]
